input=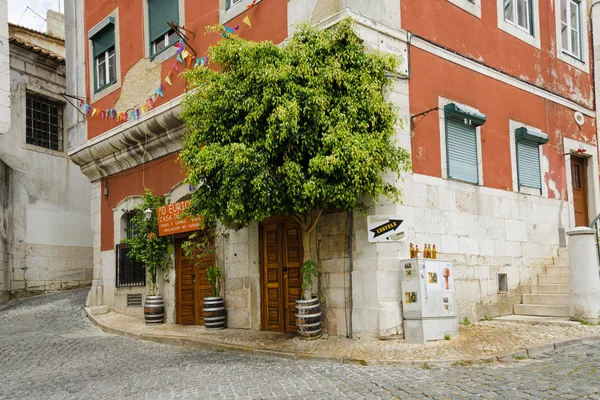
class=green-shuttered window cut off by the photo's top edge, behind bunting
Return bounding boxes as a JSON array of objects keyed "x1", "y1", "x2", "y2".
[{"x1": 148, "y1": 0, "x2": 179, "y2": 57}]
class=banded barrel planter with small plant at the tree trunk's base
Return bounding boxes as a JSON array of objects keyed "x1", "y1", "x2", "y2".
[{"x1": 296, "y1": 260, "x2": 323, "y2": 339}]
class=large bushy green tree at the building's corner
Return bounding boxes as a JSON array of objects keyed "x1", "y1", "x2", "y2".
[{"x1": 179, "y1": 19, "x2": 410, "y2": 294}]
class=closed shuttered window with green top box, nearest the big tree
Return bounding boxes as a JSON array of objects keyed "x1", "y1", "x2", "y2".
[{"x1": 444, "y1": 103, "x2": 486, "y2": 184}]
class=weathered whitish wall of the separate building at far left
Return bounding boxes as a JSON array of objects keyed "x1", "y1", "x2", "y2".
[{"x1": 0, "y1": 45, "x2": 92, "y2": 296}]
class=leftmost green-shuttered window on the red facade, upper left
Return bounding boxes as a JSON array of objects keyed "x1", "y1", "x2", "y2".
[{"x1": 88, "y1": 17, "x2": 117, "y2": 93}]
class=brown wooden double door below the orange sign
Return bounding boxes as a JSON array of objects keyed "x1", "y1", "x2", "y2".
[{"x1": 175, "y1": 237, "x2": 213, "y2": 325}]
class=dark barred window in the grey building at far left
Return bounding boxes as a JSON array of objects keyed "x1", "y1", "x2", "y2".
[{"x1": 26, "y1": 93, "x2": 63, "y2": 151}]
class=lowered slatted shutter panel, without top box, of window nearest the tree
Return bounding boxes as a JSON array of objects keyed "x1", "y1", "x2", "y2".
[{"x1": 446, "y1": 119, "x2": 479, "y2": 183}]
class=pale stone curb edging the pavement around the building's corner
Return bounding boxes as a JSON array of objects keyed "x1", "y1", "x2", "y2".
[{"x1": 85, "y1": 307, "x2": 600, "y2": 368}]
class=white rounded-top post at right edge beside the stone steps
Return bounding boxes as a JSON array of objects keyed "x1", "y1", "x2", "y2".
[{"x1": 567, "y1": 226, "x2": 600, "y2": 323}]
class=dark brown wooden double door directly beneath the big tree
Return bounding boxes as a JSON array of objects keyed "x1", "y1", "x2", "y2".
[{"x1": 261, "y1": 219, "x2": 303, "y2": 333}]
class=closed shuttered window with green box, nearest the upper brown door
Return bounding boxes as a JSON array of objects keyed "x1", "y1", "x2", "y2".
[{"x1": 515, "y1": 127, "x2": 549, "y2": 194}]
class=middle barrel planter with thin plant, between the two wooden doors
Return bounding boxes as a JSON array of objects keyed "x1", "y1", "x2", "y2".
[{"x1": 182, "y1": 229, "x2": 226, "y2": 330}]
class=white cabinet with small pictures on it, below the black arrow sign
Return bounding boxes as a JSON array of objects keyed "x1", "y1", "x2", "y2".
[{"x1": 401, "y1": 258, "x2": 458, "y2": 343}]
